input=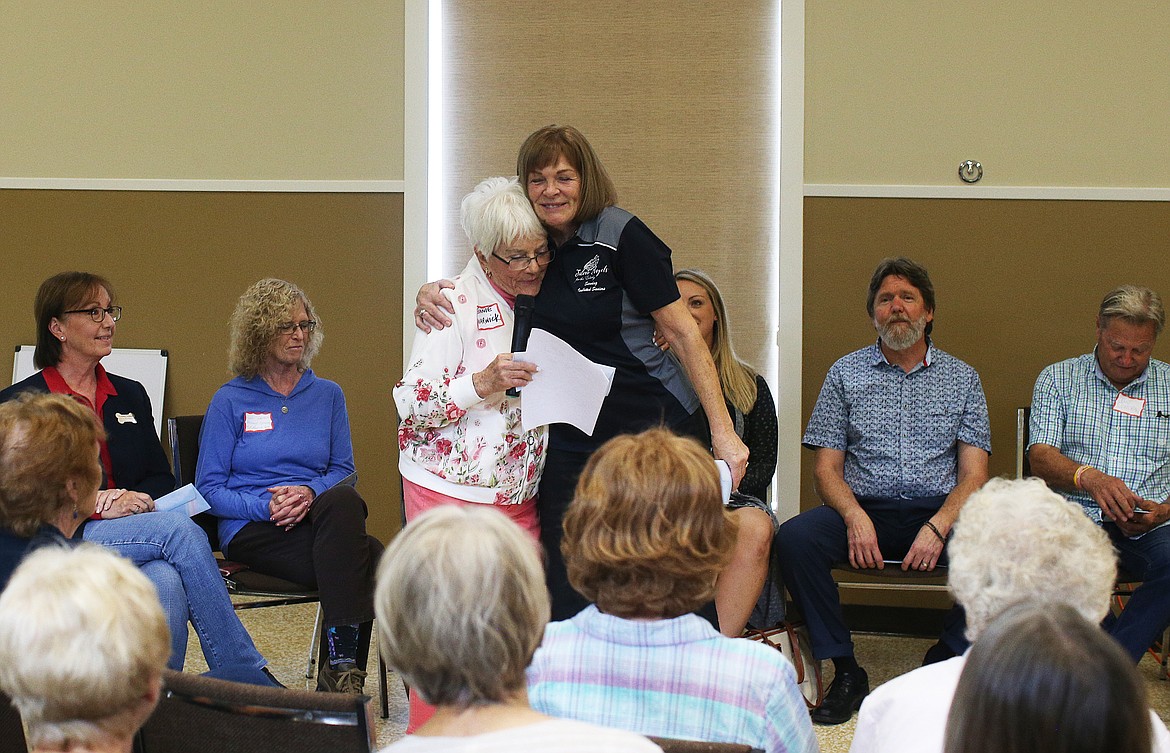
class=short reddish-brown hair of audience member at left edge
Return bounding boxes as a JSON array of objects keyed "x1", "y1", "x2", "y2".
[{"x1": 0, "y1": 393, "x2": 105, "y2": 537}]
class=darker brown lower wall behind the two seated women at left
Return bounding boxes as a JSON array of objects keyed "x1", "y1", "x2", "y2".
[{"x1": 0, "y1": 191, "x2": 402, "y2": 540}]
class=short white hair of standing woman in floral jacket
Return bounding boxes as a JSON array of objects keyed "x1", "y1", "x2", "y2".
[{"x1": 459, "y1": 177, "x2": 545, "y2": 255}]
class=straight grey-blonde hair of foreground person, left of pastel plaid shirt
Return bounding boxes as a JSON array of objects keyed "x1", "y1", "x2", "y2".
[{"x1": 374, "y1": 505, "x2": 549, "y2": 709}]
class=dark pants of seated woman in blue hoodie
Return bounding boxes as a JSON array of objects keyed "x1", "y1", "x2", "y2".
[{"x1": 223, "y1": 485, "x2": 384, "y2": 668}]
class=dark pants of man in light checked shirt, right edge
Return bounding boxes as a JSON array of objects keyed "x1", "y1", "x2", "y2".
[{"x1": 1104, "y1": 523, "x2": 1170, "y2": 662}]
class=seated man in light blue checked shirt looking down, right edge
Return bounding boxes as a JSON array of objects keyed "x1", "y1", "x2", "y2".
[{"x1": 1028, "y1": 285, "x2": 1170, "y2": 662}]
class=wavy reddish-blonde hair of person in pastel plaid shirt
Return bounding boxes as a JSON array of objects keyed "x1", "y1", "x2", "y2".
[{"x1": 560, "y1": 429, "x2": 736, "y2": 619}]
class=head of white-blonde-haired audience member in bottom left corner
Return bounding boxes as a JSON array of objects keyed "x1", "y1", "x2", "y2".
[{"x1": 0, "y1": 544, "x2": 171, "y2": 753}]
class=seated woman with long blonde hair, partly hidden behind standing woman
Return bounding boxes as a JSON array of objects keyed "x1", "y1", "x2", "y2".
[{"x1": 674, "y1": 269, "x2": 779, "y2": 637}]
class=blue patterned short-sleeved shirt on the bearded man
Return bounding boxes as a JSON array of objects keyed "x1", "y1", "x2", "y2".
[{"x1": 803, "y1": 343, "x2": 991, "y2": 499}]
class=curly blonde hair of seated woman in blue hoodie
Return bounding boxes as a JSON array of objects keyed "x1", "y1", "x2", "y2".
[{"x1": 227, "y1": 277, "x2": 325, "y2": 379}]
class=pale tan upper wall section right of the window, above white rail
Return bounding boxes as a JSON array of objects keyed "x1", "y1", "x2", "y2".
[{"x1": 805, "y1": 0, "x2": 1170, "y2": 187}]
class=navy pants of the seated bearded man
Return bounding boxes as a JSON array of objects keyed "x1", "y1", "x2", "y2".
[{"x1": 776, "y1": 497, "x2": 969, "y2": 659}]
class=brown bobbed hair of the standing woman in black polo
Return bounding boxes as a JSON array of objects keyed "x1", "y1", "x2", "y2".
[{"x1": 516, "y1": 125, "x2": 618, "y2": 226}]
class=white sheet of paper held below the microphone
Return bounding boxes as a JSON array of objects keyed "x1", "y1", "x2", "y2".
[{"x1": 514, "y1": 330, "x2": 614, "y2": 435}]
